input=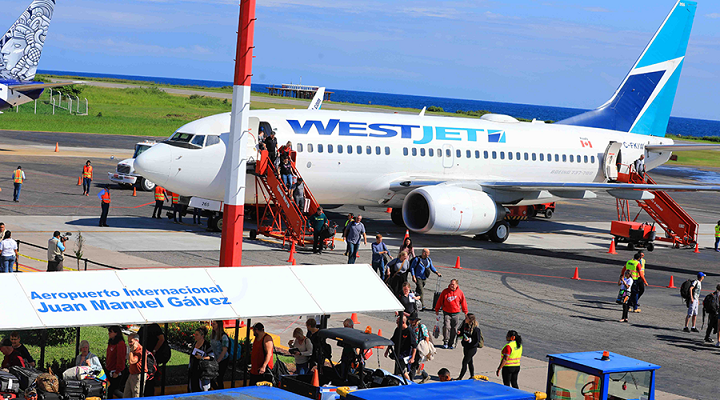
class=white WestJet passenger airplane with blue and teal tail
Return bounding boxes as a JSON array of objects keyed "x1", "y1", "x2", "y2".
[{"x1": 135, "y1": 0, "x2": 720, "y2": 242}]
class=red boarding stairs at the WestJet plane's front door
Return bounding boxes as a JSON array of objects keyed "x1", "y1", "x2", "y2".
[{"x1": 254, "y1": 151, "x2": 319, "y2": 245}]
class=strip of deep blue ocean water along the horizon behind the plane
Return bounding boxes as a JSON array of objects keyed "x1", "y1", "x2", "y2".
[{"x1": 38, "y1": 70, "x2": 720, "y2": 137}]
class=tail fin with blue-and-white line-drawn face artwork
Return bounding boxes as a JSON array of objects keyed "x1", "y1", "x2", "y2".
[{"x1": 0, "y1": 0, "x2": 55, "y2": 82}]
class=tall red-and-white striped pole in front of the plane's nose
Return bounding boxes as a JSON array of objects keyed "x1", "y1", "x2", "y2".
[{"x1": 220, "y1": 0, "x2": 255, "y2": 267}]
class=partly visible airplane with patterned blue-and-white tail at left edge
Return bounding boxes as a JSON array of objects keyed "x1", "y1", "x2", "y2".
[{"x1": 0, "y1": 0, "x2": 80, "y2": 110}]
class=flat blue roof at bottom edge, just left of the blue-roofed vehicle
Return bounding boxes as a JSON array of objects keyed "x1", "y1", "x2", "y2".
[{"x1": 347, "y1": 380, "x2": 535, "y2": 400}]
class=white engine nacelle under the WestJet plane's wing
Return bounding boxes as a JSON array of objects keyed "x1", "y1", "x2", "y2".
[{"x1": 402, "y1": 185, "x2": 505, "y2": 235}]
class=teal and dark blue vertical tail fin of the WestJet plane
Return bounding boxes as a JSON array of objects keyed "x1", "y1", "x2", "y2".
[{"x1": 558, "y1": 0, "x2": 697, "y2": 136}]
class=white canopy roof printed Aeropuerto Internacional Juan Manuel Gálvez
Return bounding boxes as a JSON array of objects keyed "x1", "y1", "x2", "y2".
[{"x1": 0, "y1": 264, "x2": 403, "y2": 330}]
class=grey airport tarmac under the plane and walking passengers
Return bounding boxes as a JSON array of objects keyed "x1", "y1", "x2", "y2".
[{"x1": 0, "y1": 131, "x2": 720, "y2": 399}]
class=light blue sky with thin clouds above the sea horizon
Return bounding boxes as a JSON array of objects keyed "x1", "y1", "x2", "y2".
[{"x1": 0, "y1": 0, "x2": 720, "y2": 120}]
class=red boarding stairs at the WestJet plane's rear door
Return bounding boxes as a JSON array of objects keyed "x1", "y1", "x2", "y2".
[{"x1": 618, "y1": 172, "x2": 699, "y2": 248}]
